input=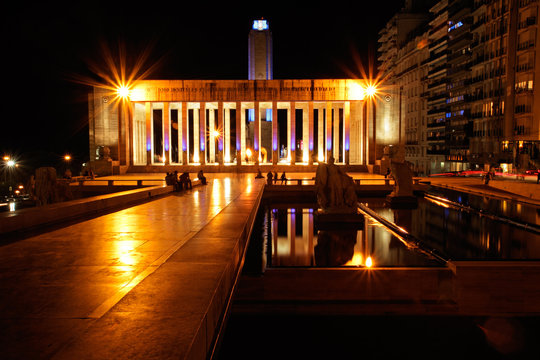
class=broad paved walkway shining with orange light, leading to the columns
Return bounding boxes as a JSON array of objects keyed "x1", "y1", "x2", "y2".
[{"x1": 0, "y1": 174, "x2": 264, "y2": 359}]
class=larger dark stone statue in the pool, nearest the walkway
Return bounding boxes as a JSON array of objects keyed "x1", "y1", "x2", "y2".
[{"x1": 315, "y1": 157, "x2": 358, "y2": 213}]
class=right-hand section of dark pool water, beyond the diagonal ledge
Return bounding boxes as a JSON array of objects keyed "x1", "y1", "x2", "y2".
[{"x1": 368, "y1": 196, "x2": 540, "y2": 260}]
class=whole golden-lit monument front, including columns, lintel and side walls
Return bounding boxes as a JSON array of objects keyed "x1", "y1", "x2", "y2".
[{"x1": 89, "y1": 79, "x2": 398, "y2": 173}]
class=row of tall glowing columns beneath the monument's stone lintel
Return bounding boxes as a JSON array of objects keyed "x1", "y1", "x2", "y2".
[{"x1": 129, "y1": 101, "x2": 370, "y2": 165}]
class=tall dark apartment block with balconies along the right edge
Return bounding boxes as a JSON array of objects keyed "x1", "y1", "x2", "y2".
[{"x1": 384, "y1": 0, "x2": 540, "y2": 174}]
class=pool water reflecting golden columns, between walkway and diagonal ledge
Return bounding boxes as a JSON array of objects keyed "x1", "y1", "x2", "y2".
[{"x1": 263, "y1": 207, "x2": 441, "y2": 267}]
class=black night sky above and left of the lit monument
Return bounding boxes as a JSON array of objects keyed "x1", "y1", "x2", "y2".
[{"x1": 0, "y1": 0, "x2": 403, "y2": 169}]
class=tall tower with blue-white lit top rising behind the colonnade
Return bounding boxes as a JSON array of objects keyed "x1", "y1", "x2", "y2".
[{"x1": 248, "y1": 19, "x2": 274, "y2": 80}]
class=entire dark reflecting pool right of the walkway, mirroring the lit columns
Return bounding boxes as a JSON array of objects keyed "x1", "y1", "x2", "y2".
[{"x1": 246, "y1": 191, "x2": 540, "y2": 270}]
